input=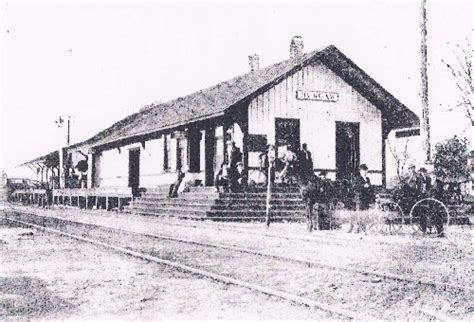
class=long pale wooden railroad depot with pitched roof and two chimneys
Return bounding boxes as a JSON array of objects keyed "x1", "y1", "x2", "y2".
[{"x1": 20, "y1": 37, "x2": 419, "y2": 197}]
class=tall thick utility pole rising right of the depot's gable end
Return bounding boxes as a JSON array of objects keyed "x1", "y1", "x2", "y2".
[{"x1": 420, "y1": 0, "x2": 431, "y2": 164}]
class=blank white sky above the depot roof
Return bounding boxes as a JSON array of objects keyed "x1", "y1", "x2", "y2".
[{"x1": 0, "y1": 0, "x2": 473, "y2": 176}]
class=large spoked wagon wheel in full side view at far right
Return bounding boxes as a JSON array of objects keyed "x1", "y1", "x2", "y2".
[{"x1": 410, "y1": 198, "x2": 451, "y2": 235}]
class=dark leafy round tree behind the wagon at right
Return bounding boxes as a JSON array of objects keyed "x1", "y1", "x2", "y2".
[{"x1": 433, "y1": 136, "x2": 470, "y2": 181}]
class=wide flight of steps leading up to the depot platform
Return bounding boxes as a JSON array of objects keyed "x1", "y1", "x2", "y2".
[{"x1": 129, "y1": 186, "x2": 305, "y2": 220}]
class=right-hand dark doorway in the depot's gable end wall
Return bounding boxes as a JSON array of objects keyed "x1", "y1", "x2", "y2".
[{"x1": 336, "y1": 122, "x2": 360, "y2": 180}]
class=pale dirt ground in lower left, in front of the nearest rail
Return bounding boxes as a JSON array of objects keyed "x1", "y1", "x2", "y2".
[{"x1": 0, "y1": 220, "x2": 327, "y2": 321}]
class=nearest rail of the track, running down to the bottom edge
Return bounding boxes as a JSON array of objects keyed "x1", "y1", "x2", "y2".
[{"x1": 5, "y1": 214, "x2": 377, "y2": 321}]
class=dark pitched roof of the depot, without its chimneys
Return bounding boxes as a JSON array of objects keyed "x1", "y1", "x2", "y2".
[{"x1": 74, "y1": 46, "x2": 419, "y2": 150}]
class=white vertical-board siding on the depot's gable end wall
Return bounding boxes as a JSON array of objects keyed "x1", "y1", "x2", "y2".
[{"x1": 248, "y1": 63, "x2": 382, "y2": 183}]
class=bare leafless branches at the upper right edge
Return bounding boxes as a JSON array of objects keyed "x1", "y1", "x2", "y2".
[{"x1": 441, "y1": 41, "x2": 474, "y2": 126}]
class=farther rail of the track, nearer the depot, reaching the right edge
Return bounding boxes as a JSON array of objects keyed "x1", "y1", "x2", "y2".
[{"x1": 4, "y1": 213, "x2": 474, "y2": 292}]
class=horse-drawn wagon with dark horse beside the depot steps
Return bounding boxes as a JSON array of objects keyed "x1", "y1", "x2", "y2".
[{"x1": 302, "y1": 175, "x2": 470, "y2": 236}]
